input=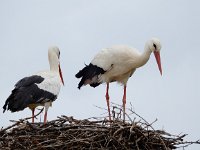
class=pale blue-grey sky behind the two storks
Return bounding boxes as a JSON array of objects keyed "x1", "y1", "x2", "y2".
[{"x1": 0, "y1": 0, "x2": 200, "y2": 150}]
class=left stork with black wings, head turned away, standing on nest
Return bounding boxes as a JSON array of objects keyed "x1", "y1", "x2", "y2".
[{"x1": 3, "y1": 47, "x2": 64, "y2": 124}]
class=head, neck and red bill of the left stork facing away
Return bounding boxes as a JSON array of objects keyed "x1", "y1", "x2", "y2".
[{"x1": 48, "y1": 46, "x2": 64, "y2": 85}]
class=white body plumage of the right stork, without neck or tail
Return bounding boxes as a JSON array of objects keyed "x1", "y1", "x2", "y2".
[{"x1": 91, "y1": 45, "x2": 141, "y2": 84}]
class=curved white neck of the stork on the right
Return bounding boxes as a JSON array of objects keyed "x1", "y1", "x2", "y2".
[{"x1": 137, "y1": 43, "x2": 152, "y2": 67}]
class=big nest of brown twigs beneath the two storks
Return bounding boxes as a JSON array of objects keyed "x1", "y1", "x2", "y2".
[{"x1": 0, "y1": 105, "x2": 200, "y2": 150}]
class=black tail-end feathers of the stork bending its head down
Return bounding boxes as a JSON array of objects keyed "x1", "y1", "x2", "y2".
[{"x1": 75, "y1": 63, "x2": 105, "y2": 89}]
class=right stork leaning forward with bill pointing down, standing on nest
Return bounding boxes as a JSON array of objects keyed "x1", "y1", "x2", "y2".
[{"x1": 76, "y1": 38, "x2": 162, "y2": 121}]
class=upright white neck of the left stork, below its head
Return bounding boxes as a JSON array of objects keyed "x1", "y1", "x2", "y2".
[{"x1": 49, "y1": 53, "x2": 59, "y2": 72}]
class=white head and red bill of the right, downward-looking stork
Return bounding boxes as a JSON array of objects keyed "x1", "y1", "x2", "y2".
[{"x1": 146, "y1": 38, "x2": 162, "y2": 75}]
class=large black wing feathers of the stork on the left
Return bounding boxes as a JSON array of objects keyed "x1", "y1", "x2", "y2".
[{"x1": 3, "y1": 75, "x2": 57, "y2": 112}]
